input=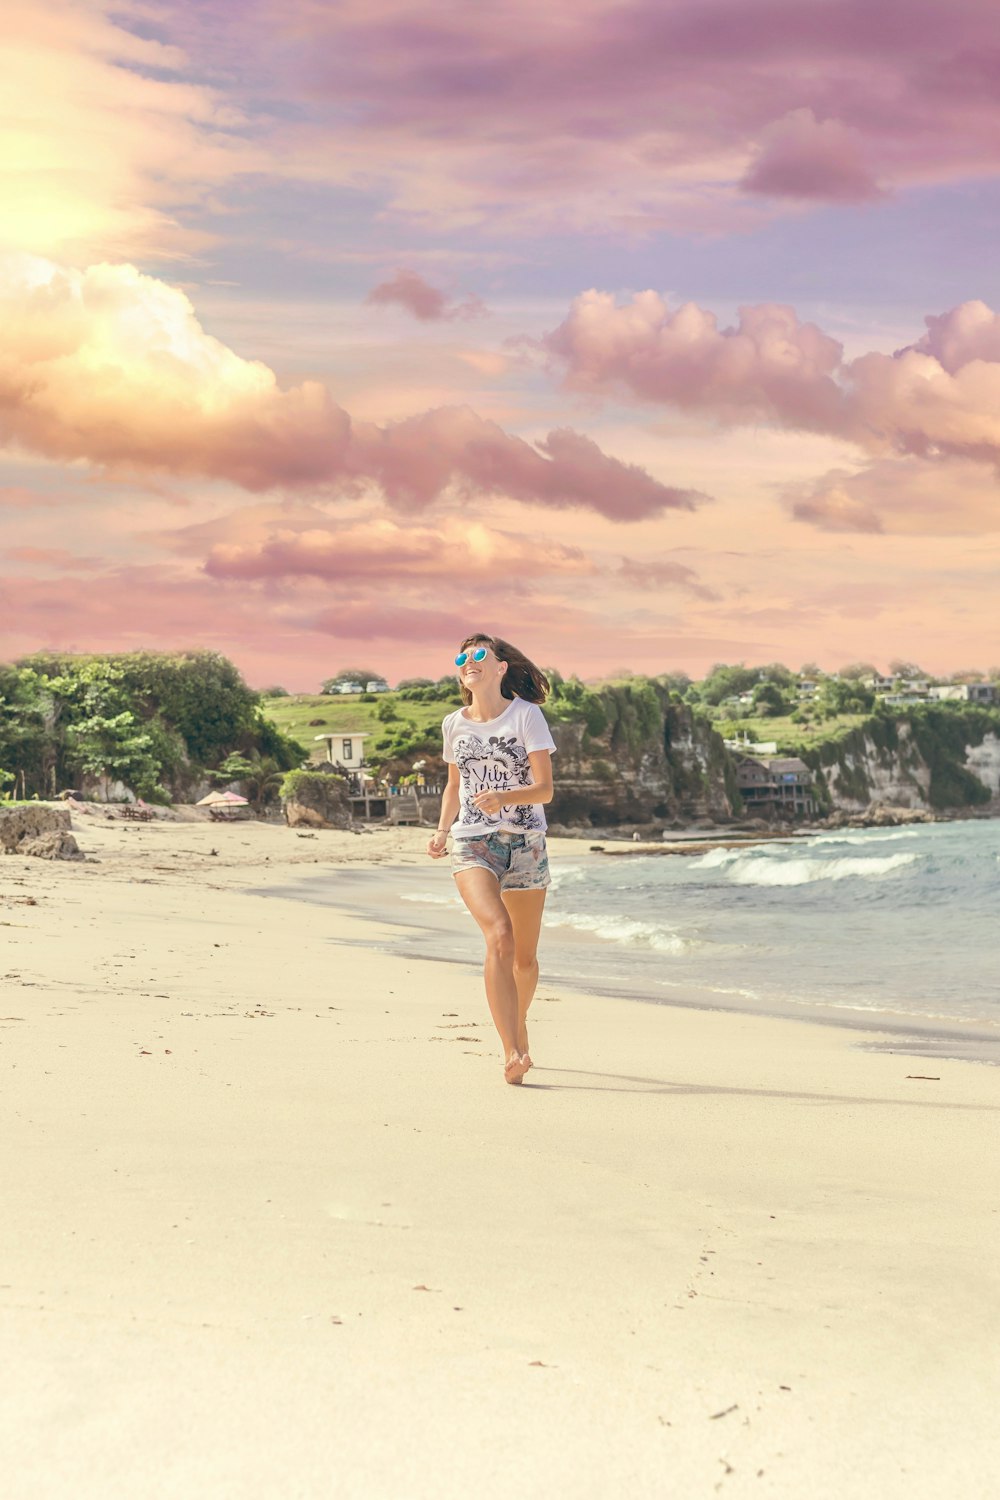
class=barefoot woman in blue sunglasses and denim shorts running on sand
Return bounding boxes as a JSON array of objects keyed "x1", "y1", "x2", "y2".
[{"x1": 427, "y1": 635, "x2": 555, "y2": 1083}]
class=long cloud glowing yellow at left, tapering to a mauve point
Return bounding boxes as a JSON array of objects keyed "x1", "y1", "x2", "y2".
[{"x1": 0, "y1": 257, "x2": 705, "y2": 519}]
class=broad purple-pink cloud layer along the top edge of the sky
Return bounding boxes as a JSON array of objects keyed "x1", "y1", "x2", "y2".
[{"x1": 174, "y1": 0, "x2": 1000, "y2": 233}]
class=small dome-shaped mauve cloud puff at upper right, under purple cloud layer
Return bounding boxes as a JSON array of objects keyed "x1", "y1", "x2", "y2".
[{"x1": 741, "y1": 110, "x2": 882, "y2": 203}]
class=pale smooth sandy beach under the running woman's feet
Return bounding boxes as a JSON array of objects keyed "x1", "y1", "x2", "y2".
[{"x1": 0, "y1": 816, "x2": 1000, "y2": 1500}]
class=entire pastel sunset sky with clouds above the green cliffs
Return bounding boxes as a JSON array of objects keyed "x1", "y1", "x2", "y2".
[{"x1": 0, "y1": 0, "x2": 1000, "y2": 692}]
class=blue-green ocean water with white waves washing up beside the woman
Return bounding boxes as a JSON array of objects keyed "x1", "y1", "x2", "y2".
[{"x1": 268, "y1": 821, "x2": 1000, "y2": 1062}]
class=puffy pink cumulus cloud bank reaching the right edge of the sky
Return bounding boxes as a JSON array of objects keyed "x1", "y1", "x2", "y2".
[{"x1": 543, "y1": 291, "x2": 1000, "y2": 464}]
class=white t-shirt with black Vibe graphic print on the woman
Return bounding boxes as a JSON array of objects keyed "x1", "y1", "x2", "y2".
[{"x1": 441, "y1": 698, "x2": 556, "y2": 839}]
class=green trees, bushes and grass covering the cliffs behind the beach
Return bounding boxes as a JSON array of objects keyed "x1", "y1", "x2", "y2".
[{"x1": 0, "y1": 653, "x2": 1000, "y2": 818}]
